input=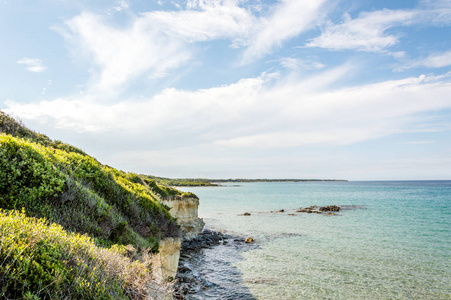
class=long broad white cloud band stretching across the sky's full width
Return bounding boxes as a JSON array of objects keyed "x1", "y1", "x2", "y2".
[{"x1": 6, "y1": 66, "x2": 451, "y2": 151}]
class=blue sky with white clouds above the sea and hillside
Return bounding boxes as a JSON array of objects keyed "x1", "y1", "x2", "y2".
[{"x1": 0, "y1": 0, "x2": 451, "y2": 180}]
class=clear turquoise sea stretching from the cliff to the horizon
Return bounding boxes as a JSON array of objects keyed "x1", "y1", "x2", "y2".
[{"x1": 179, "y1": 181, "x2": 451, "y2": 300}]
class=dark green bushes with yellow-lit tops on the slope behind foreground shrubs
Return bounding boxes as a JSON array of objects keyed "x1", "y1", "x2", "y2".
[{"x1": 0, "y1": 134, "x2": 179, "y2": 250}]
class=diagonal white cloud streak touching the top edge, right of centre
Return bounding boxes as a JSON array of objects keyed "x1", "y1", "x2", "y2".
[{"x1": 243, "y1": 0, "x2": 326, "y2": 62}]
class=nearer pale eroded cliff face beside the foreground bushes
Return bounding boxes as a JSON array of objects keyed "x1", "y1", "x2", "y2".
[{"x1": 152, "y1": 237, "x2": 182, "y2": 283}]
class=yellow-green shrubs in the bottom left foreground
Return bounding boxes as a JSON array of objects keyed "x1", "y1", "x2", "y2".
[{"x1": 0, "y1": 210, "x2": 150, "y2": 299}]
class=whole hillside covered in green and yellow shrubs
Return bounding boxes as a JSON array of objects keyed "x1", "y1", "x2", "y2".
[{"x1": 0, "y1": 111, "x2": 194, "y2": 299}]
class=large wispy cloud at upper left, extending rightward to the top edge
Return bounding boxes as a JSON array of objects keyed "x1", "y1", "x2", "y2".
[{"x1": 57, "y1": 0, "x2": 326, "y2": 93}]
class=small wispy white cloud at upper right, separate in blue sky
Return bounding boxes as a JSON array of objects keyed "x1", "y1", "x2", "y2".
[{"x1": 306, "y1": 9, "x2": 416, "y2": 52}]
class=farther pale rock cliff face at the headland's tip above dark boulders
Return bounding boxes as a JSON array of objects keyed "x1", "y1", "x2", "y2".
[{"x1": 162, "y1": 196, "x2": 205, "y2": 240}]
